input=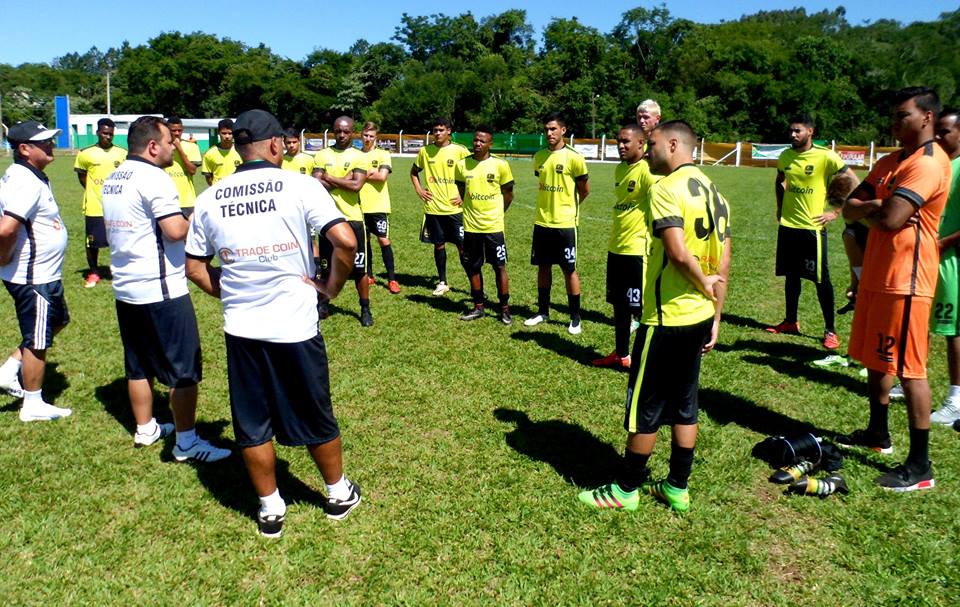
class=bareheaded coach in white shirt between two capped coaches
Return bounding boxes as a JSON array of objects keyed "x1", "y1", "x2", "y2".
[{"x1": 103, "y1": 116, "x2": 230, "y2": 462}]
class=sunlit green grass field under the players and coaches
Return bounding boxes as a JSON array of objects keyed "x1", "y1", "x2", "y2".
[{"x1": 0, "y1": 150, "x2": 960, "y2": 606}]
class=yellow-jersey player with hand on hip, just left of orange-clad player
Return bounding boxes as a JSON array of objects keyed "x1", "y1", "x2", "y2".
[{"x1": 767, "y1": 114, "x2": 860, "y2": 350}]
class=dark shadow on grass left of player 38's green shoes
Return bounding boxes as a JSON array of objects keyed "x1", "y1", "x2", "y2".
[{"x1": 493, "y1": 407, "x2": 620, "y2": 488}]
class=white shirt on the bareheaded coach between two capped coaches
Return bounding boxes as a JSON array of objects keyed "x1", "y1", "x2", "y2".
[{"x1": 103, "y1": 156, "x2": 187, "y2": 305}]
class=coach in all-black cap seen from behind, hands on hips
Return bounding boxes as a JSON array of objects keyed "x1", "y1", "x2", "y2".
[{"x1": 187, "y1": 110, "x2": 360, "y2": 537}]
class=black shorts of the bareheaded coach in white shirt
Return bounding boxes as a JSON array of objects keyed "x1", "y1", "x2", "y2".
[{"x1": 117, "y1": 295, "x2": 203, "y2": 388}]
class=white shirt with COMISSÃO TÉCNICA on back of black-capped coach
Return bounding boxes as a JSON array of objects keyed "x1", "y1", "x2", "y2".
[{"x1": 187, "y1": 162, "x2": 344, "y2": 343}]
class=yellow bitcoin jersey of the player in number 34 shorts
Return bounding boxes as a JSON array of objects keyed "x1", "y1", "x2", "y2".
[{"x1": 533, "y1": 145, "x2": 587, "y2": 228}]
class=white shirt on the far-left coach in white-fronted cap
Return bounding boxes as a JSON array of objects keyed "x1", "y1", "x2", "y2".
[{"x1": 0, "y1": 162, "x2": 67, "y2": 285}]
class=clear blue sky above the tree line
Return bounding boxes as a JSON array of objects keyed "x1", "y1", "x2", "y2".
[{"x1": 0, "y1": 0, "x2": 957, "y2": 65}]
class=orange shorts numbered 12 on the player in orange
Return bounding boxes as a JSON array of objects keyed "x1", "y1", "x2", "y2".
[{"x1": 848, "y1": 289, "x2": 933, "y2": 379}]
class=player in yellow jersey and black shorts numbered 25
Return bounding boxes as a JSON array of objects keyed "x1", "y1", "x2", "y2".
[{"x1": 455, "y1": 125, "x2": 513, "y2": 325}]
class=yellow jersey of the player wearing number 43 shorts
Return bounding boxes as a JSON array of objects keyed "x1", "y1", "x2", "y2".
[{"x1": 607, "y1": 160, "x2": 657, "y2": 255}]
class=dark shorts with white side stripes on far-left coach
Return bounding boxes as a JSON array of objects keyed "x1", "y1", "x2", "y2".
[{"x1": 3, "y1": 280, "x2": 70, "y2": 350}]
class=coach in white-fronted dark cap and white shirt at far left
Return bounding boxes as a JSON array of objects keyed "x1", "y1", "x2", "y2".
[{"x1": 0, "y1": 120, "x2": 71, "y2": 422}]
